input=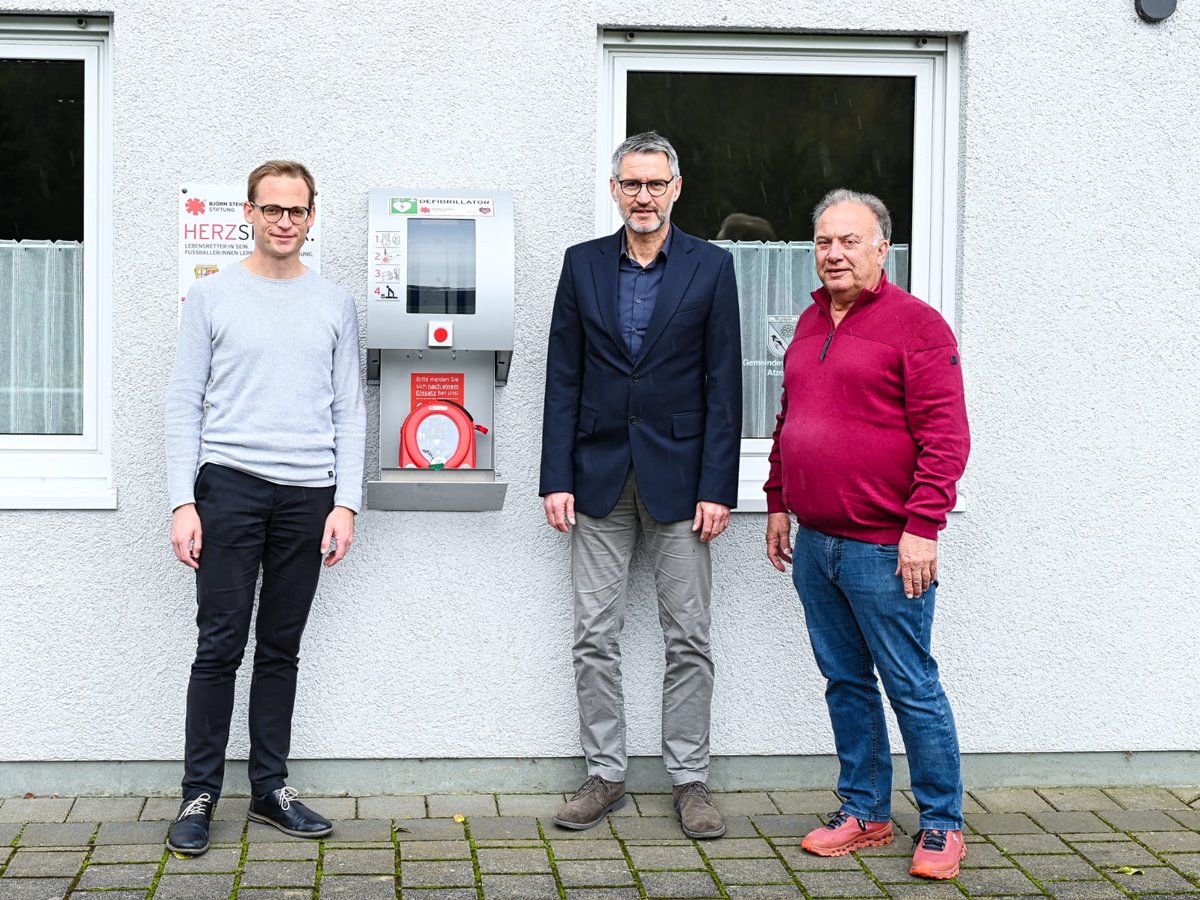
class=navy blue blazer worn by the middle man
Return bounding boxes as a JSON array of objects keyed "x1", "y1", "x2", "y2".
[{"x1": 539, "y1": 228, "x2": 742, "y2": 522}]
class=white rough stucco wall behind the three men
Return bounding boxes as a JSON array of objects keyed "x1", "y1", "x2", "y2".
[{"x1": 0, "y1": 0, "x2": 1200, "y2": 777}]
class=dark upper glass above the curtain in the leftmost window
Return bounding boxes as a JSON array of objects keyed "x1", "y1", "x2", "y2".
[{"x1": 0, "y1": 59, "x2": 84, "y2": 241}]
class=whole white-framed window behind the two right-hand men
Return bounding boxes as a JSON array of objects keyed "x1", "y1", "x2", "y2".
[{"x1": 596, "y1": 31, "x2": 959, "y2": 511}]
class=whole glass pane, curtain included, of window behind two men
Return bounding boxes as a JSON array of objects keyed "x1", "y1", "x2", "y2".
[{"x1": 625, "y1": 72, "x2": 916, "y2": 438}]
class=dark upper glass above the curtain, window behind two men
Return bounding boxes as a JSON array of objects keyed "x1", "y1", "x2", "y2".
[{"x1": 626, "y1": 72, "x2": 916, "y2": 244}]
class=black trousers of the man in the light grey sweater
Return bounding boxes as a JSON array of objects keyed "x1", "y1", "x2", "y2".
[{"x1": 184, "y1": 464, "x2": 334, "y2": 800}]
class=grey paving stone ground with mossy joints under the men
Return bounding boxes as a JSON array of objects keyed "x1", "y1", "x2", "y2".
[{"x1": 0, "y1": 786, "x2": 1200, "y2": 900}]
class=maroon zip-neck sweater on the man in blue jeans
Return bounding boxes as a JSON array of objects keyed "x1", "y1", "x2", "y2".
[{"x1": 763, "y1": 275, "x2": 971, "y2": 544}]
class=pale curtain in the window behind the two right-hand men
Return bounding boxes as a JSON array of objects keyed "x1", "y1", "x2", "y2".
[{"x1": 713, "y1": 241, "x2": 908, "y2": 438}]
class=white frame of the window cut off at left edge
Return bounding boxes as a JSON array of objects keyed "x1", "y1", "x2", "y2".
[{"x1": 0, "y1": 16, "x2": 116, "y2": 509}]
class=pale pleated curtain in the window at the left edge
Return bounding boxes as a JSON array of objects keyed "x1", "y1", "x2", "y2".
[{"x1": 0, "y1": 240, "x2": 83, "y2": 434}]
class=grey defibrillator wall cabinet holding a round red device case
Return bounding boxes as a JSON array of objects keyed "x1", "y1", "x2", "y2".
[{"x1": 367, "y1": 187, "x2": 515, "y2": 511}]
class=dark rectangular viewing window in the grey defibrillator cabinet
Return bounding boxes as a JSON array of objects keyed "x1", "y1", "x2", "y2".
[{"x1": 406, "y1": 218, "x2": 475, "y2": 316}]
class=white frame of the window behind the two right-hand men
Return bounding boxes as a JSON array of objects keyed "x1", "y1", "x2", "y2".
[{"x1": 595, "y1": 30, "x2": 961, "y2": 512}]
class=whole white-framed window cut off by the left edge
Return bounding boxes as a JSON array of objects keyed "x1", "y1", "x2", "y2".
[{"x1": 0, "y1": 17, "x2": 116, "y2": 509}]
